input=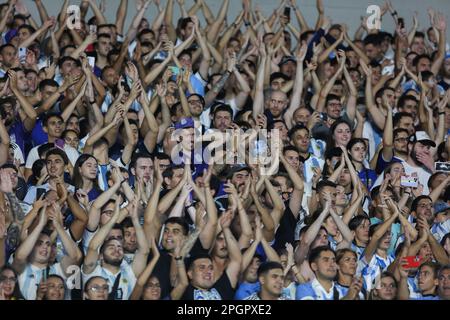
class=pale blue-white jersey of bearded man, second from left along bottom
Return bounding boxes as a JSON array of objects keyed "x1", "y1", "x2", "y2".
[{"x1": 81, "y1": 259, "x2": 136, "y2": 300}]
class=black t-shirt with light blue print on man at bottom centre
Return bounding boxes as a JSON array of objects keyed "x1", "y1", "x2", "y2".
[{"x1": 182, "y1": 272, "x2": 235, "y2": 300}]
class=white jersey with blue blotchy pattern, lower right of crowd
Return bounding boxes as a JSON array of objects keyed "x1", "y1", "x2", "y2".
[{"x1": 356, "y1": 253, "x2": 395, "y2": 292}]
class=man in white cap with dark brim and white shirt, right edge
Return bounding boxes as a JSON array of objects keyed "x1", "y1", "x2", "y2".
[{"x1": 403, "y1": 131, "x2": 436, "y2": 194}]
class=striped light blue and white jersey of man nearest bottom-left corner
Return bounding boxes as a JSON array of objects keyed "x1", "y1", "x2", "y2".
[{"x1": 18, "y1": 263, "x2": 66, "y2": 300}]
